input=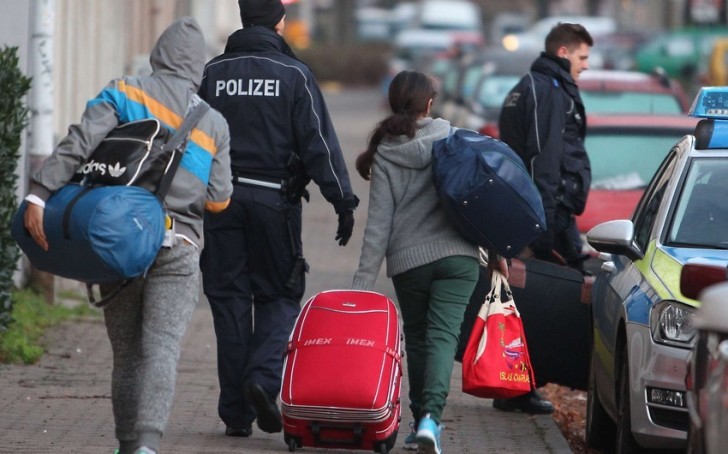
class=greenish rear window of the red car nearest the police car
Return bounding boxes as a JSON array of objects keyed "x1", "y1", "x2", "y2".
[{"x1": 585, "y1": 129, "x2": 681, "y2": 190}]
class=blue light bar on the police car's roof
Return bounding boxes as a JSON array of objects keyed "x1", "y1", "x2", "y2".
[{"x1": 688, "y1": 87, "x2": 728, "y2": 150}]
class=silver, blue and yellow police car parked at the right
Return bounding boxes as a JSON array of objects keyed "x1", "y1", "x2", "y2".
[{"x1": 586, "y1": 87, "x2": 728, "y2": 453}]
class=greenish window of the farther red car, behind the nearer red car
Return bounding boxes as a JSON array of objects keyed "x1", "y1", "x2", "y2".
[{"x1": 581, "y1": 90, "x2": 683, "y2": 114}]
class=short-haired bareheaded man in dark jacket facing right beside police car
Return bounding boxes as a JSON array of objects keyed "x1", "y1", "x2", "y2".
[{"x1": 493, "y1": 23, "x2": 594, "y2": 413}]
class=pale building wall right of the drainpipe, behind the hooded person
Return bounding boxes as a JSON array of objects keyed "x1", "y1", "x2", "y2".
[{"x1": 49, "y1": 0, "x2": 240, "y2": 142}]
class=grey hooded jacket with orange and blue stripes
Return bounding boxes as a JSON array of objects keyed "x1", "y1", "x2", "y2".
[{"x1": 31, "y1": 17, "x2": 232, "y2": 248}]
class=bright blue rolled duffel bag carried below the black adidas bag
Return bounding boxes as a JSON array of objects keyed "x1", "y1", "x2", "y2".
[{"x1": 11, "y1": 184, "x2": 166, "y2": 283}]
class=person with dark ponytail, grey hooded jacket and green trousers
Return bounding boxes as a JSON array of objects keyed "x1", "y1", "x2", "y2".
[{"x1": 352, "y1": 71, "x2": 507, "y2": 454}]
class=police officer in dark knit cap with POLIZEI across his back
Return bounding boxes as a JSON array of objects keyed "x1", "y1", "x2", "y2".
[{"x1": 199, "y1": 0, "x2": 358, "y2": 437}]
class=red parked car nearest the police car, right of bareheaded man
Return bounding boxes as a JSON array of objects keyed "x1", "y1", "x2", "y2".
[{"x1": 576, "y1": 115, "x2": 698, "y2": 233}]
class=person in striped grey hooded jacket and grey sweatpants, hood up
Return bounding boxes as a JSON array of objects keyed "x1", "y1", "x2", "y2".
[{"x1": 24, "y1": 17, "x2": 232, "y2": 454}]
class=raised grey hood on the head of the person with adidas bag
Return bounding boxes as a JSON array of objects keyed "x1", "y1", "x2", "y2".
[{"x1": 149, "y1": 17, "x2": 206, "y2": 90}]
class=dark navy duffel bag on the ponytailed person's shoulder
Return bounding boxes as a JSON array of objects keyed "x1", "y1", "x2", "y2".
[{"x1": 432, "y1": 129, "x2": 546, "y2": 258}]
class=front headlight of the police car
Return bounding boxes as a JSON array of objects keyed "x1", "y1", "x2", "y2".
[{"x1": 650, "y1": 301, "x2": 696, "y2": 348}]
